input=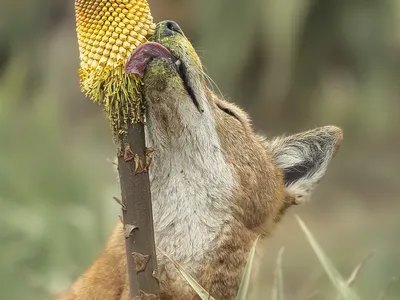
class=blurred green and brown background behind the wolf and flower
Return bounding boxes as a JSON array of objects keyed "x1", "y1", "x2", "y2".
[{"x1": 0, "y1": 0, "x2": 400, "y2": 300}]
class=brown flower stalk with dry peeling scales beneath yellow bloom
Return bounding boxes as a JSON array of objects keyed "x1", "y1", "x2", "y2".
[{"x1": 118, "y1": 122, "x2": 159, "y2": 300}]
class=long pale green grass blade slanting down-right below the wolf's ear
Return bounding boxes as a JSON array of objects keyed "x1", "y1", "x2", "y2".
[{"x1": 296, "y1": 216, "x2": 361, "y2": 300}]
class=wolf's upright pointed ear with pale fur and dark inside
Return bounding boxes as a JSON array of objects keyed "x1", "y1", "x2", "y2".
[{"x1": 266, "y1": 126, "x2": 343, "y2": 204}]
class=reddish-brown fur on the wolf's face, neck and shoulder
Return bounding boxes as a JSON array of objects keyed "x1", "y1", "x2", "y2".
[{"x1": 58, "y1": 20, "x2": 341, "y2": 300}]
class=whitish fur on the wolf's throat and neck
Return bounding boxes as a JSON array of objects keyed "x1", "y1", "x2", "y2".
[{"x1": 146, "y1": 96, "x2": 235, "y2": 274}]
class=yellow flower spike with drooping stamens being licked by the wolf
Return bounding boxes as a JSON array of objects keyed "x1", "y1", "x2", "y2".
[{"x1": 75, "y1": 0, "x2": 155, "y2": 140}]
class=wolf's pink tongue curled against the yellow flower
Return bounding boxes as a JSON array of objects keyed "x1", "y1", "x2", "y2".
[{"x1": 126, "y1": 42, "x2": 176, "y2": 78}]
